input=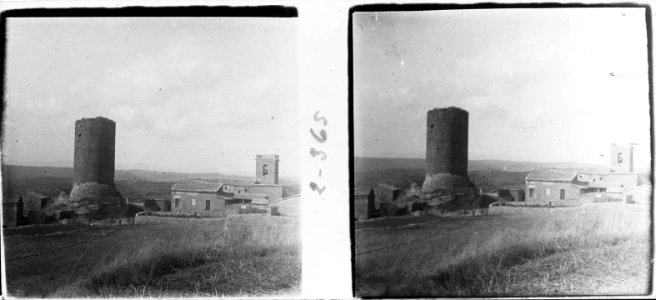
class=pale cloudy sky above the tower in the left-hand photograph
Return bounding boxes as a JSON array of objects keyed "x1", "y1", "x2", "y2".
[{"x1": 3, "y1": 18, "x2": 300, "y2": 176}]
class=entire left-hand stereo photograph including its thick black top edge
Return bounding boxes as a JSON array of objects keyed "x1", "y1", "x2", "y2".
[{"x1": 2, "y1": 6, "x2": 301, "y2": 298}]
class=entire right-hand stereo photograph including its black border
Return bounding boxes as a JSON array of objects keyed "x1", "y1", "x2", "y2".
[{"x1": 349, "y1": 4, "x2": 653, "y2": 298}]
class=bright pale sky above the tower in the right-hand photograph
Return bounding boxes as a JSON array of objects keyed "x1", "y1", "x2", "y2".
[{"x1": 353, "y1": 8, "x2": 650, "y2": 169}]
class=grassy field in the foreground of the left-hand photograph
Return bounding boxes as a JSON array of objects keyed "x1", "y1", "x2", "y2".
[{"x1": 4, "y1": 216, "x2": 301, "y2": 297}]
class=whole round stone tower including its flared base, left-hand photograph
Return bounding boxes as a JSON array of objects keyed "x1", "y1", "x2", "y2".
[{"x1": 69, "y1": 117, "x2": 122, "y2": 205}]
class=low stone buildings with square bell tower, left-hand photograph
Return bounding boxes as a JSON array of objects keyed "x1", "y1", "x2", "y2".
[{"x1": 171, "y1": 154, "x2": 284, "y2": 215}]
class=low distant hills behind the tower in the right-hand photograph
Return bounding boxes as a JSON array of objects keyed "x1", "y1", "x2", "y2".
[{"x1": 354, "y1": 157, "x2": 608, "y2": 174}]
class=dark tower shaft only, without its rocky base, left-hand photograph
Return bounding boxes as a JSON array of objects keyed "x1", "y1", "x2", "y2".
[{"x1": 73, "y1": 117, "x2": 116, "y2": 187}]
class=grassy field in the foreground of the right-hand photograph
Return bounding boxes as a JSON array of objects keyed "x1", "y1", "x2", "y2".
[{"x1": 355, "y1": 204, "x2": 651, "y2": 297}]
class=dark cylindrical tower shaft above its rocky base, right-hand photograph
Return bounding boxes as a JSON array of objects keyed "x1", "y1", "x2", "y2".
[{"x1": 426, "y1": 107, "x2": 469, "y2": 178}]
